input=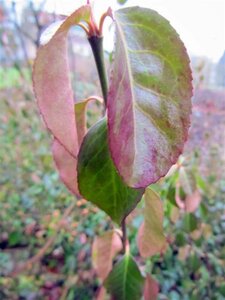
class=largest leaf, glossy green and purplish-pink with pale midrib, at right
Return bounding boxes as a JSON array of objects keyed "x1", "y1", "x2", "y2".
[{"x1": 108, "y1": 7, "x2": 192, "y2": 188}]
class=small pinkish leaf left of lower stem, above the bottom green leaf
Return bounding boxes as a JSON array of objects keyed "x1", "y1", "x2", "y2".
[{"x1": 92, "y1": 231, "x2": 122, "y2": 281}]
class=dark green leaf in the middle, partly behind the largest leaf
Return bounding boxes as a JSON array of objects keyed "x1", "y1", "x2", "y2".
[{"x1": 77, "y1": 119, "x2": 144, "y2": 224}]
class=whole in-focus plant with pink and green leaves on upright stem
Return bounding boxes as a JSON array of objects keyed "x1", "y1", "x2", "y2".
[{"x1": 33, "y1": 2, "x2": 192, "y2": 300}]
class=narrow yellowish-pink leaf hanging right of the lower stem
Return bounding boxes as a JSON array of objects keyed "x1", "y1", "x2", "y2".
[{"x1": 138, "y1": 189, "x2": 166, "y2": 258}]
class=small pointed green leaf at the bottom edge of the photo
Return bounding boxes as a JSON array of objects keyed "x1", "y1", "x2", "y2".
[{"x1": 104, "y1": 254, "x2": 144, "y2": 300}]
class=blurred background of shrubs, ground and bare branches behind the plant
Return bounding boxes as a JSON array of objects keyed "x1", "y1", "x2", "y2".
[{"x1": 0, "y1": 0, "x2": 225, "y2": 300}]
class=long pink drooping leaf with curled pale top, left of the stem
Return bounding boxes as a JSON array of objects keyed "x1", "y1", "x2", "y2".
[{"x1": 33, "y1": 6, "x2": 90, "y2": 157}]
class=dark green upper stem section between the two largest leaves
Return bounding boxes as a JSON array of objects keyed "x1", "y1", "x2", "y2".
[{"x1": 88, "y1": 36, "x2": 108, "y2": 106}]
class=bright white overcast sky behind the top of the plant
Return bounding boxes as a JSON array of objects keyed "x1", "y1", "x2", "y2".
[{"x1": 17, "y1": 0, "x2": 225, "y2": 62}]
